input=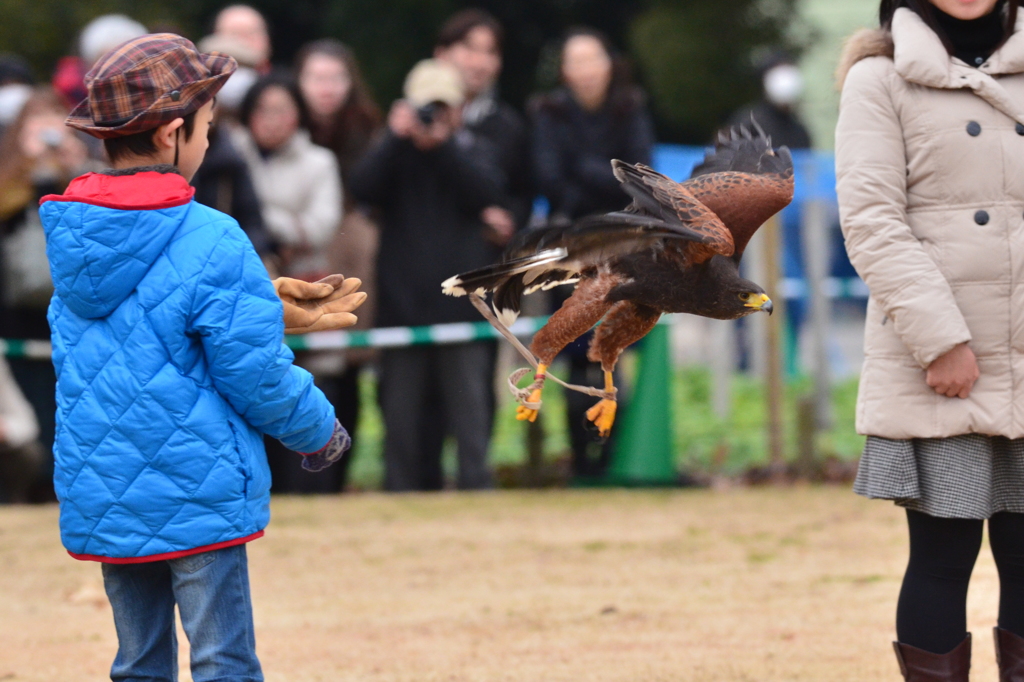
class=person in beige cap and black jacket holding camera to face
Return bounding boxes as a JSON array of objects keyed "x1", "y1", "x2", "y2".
[{"x1": 349, "y1": 59, "x2": 505, "y2": 491}]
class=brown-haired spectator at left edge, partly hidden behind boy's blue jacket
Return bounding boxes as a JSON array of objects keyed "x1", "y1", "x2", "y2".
[{"x1": 0, "y1": 87, "x2": 94, "y2": 501}]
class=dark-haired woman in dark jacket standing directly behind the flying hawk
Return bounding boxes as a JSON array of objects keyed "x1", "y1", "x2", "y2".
[{"x1": 528, "y1": 29, "x2": 654, "y2": 478}]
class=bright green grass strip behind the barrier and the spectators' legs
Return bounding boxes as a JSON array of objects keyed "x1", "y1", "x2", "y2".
[{"x1": 351, "y1": 358, "x2": 863, "y2": 489}]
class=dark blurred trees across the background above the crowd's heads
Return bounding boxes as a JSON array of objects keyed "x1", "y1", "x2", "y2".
[{"x1": 0, "y1": 0, "x2": 797, "y2": 143}]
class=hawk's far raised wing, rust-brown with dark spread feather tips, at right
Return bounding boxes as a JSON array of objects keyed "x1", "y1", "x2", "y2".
[{"x1": 683, "y1": 120, "x2": 794, "y2": 261}]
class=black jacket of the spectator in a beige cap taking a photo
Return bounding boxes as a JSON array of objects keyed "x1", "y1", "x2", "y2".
[{"x1": 349, "y1": 131, "x2": 505, "y2": 327}]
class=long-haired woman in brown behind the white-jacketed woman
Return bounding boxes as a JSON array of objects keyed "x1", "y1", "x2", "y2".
[{"x1": 295, "y1": 38, "x2": 381, "y2": 486}]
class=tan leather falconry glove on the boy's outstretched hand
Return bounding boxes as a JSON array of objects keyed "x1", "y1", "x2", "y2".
[{"x1": 273, "y1": 274, "x2": 367, "y2": 334}]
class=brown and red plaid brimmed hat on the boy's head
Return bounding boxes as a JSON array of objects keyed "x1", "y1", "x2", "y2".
[{"x1": 65, "y1": 33, "x2": 238, "y2": 138}]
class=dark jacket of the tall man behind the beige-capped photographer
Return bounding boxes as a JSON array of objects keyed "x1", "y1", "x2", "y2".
[{"x1": 463, "y1": 95, "x2": 535, "y2": 228}]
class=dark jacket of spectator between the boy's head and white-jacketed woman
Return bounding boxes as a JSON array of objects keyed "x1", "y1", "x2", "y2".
[{"x1": 191, "y1": 129, "x2": 275, "y2": 256}]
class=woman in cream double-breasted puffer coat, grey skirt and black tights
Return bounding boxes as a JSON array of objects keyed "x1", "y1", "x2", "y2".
[{"x1": 836, "y1": 0, "x2": 1024, "y2": 681}]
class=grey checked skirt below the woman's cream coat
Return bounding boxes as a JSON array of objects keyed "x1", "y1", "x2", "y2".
[{"x1": 853, "y1": 433, "x2": 1024, "y2": 519}]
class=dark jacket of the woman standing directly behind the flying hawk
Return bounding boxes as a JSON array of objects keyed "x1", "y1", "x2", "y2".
[{"x1": 529, "y1": 88, "x2": 654, "y2": 218}]
